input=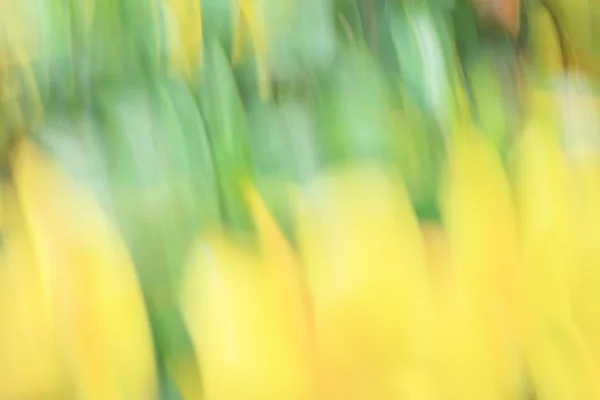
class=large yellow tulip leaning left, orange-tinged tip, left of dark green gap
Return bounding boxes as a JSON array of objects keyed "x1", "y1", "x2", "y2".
[{"x1": 13, "y1": 141, "x2": 156, "y2": 400}]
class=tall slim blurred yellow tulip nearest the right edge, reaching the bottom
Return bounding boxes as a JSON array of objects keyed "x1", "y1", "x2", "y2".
[{"x1": 515, "y1": 102, "x2": 600, "y2": 400}]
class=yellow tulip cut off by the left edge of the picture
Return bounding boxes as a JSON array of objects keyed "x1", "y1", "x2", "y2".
[{"x1": 0, "y1": 187, "x2": 65, "y2": 399}]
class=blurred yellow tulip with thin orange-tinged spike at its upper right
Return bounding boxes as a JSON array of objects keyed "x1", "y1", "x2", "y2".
[{"x1": 182, "y1": 186, "x2": 316, "y2": 400}]
